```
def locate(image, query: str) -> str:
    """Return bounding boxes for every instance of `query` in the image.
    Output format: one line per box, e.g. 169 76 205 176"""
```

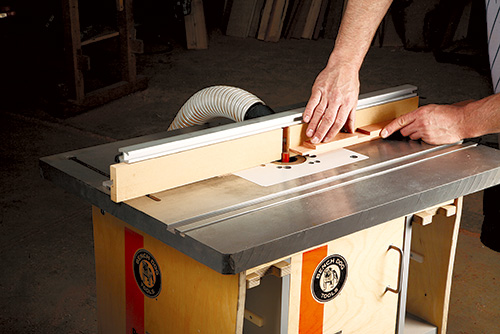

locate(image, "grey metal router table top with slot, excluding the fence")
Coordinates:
40 120 500 274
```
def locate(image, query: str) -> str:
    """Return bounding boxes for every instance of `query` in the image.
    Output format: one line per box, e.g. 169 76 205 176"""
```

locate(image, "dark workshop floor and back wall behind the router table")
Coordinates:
0 0 500 334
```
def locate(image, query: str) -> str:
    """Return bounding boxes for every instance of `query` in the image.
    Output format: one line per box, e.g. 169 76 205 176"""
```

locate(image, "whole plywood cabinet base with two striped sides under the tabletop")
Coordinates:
93 199 461 334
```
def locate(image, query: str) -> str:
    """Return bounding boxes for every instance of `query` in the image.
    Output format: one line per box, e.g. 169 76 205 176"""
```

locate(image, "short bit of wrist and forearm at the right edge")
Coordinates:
460 93 500 138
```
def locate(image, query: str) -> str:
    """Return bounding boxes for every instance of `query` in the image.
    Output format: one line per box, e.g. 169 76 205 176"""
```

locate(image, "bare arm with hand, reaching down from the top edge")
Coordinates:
303 0 392 143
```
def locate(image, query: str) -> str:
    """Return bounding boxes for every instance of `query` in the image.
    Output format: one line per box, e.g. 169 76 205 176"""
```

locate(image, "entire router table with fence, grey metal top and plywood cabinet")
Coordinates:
40 86 500 334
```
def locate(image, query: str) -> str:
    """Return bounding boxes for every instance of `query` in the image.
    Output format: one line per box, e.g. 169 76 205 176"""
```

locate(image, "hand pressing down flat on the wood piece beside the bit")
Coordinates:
303 66 359 144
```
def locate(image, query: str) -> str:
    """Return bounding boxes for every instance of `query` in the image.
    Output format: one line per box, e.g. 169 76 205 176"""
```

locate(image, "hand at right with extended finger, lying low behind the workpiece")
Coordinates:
380 104 465 145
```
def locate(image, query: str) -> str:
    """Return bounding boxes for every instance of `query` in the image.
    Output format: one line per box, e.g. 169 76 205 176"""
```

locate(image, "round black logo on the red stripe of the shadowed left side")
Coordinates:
134 249 161 298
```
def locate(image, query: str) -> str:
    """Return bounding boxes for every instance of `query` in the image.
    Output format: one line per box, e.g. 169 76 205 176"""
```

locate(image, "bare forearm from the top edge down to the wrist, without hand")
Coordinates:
327 0 392 71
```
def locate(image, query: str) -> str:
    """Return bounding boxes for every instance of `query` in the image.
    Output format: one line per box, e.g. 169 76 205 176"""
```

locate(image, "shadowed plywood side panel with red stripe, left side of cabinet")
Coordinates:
93 207 245 334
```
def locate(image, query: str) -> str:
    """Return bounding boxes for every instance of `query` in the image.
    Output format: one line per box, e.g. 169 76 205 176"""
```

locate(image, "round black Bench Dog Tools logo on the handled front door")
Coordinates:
311 254 347 303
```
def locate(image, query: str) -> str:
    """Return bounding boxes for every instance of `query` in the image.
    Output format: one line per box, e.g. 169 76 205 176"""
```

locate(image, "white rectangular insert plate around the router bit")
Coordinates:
233 148 368 187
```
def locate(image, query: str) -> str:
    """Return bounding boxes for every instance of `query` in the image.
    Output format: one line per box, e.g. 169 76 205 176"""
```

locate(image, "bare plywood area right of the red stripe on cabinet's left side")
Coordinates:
144 226 239 334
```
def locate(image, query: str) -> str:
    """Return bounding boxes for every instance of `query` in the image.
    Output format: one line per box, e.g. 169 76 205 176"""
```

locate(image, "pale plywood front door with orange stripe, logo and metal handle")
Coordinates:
288 217 405 334
